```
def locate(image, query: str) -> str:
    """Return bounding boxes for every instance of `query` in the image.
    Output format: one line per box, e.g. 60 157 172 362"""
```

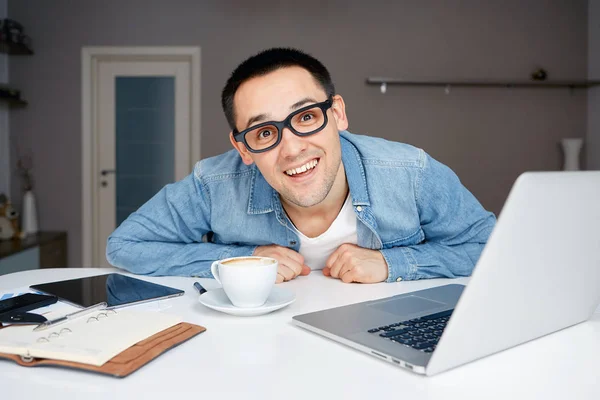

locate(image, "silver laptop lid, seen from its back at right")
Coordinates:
426 171 600 375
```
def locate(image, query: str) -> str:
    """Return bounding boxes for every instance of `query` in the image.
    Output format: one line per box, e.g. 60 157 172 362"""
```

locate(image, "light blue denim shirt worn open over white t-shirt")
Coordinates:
106 131 496 282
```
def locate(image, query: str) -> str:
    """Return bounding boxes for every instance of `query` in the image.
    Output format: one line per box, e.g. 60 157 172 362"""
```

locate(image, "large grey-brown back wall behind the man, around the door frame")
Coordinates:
8 0 588 265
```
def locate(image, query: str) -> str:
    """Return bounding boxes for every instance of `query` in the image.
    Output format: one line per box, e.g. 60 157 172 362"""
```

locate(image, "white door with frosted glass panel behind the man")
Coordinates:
93 61 191 267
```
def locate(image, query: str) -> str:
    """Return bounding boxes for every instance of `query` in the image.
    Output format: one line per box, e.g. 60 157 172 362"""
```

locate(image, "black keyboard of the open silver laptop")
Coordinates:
368 310 454 353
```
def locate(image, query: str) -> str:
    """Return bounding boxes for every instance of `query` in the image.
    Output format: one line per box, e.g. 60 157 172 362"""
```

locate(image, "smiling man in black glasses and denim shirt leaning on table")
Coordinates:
106 48 495 283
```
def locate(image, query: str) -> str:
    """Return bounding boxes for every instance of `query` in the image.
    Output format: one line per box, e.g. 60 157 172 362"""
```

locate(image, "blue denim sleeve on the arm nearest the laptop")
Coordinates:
381 155 496 282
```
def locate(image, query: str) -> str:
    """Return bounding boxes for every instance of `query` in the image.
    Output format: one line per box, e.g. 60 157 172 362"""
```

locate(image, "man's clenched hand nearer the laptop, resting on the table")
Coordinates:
323 243 388 283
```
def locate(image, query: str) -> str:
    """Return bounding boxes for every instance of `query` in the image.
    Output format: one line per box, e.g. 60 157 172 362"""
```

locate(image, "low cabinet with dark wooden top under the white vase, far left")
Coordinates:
0 232 68 275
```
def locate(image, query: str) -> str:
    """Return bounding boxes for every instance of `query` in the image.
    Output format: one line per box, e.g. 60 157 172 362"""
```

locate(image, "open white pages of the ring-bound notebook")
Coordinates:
0 310 181 366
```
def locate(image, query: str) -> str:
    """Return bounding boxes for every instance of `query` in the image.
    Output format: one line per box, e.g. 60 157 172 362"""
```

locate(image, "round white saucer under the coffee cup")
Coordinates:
199 287 296 317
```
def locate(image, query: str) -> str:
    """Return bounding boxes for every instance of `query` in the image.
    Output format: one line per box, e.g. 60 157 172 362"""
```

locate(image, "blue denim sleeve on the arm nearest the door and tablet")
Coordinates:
106 170 256 277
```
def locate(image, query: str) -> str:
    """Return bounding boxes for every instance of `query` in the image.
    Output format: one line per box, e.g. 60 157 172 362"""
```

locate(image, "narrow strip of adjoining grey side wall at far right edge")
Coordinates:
585 0 600 169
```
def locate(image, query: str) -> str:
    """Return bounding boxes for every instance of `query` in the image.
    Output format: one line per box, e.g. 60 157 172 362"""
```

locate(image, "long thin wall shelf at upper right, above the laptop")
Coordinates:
367 77 600 93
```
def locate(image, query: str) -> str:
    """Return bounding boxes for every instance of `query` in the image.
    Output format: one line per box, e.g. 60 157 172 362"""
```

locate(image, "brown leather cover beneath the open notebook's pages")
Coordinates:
0 322 206 378
